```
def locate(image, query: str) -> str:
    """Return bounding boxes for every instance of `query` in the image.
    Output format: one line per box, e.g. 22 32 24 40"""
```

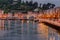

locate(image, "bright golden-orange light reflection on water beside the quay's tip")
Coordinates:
37 23 48 40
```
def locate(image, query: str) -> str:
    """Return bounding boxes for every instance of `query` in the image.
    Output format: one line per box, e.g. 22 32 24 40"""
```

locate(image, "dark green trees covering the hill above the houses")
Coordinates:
0 0 55 13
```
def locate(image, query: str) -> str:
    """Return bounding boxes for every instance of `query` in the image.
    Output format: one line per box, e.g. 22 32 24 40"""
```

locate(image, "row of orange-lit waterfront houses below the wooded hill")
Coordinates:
0 7 60 19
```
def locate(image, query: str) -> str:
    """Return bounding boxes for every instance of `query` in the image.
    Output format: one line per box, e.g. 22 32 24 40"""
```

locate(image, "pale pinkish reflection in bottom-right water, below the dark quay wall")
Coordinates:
48 28 60 40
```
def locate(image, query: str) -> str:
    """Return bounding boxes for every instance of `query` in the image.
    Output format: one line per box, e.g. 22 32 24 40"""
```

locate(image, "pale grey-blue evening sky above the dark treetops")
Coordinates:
22 0 60 7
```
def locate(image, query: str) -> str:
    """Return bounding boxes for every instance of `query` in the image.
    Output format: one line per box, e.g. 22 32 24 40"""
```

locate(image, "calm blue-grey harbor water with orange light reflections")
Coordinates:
0 20 60 40
